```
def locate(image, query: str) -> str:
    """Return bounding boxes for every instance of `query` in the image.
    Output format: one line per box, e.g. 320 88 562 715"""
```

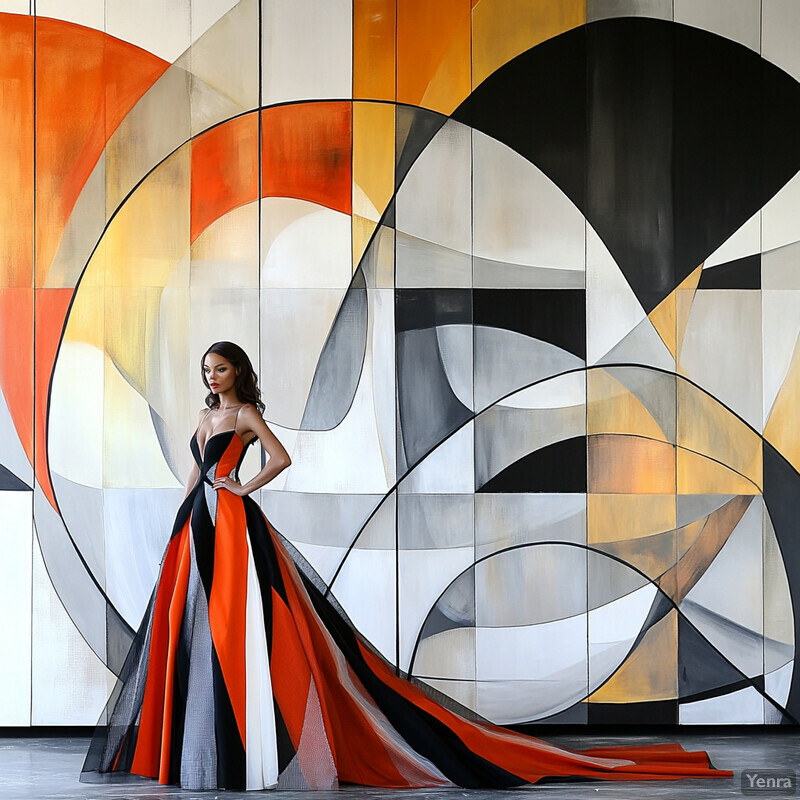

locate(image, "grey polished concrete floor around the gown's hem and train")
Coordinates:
0 728 800 800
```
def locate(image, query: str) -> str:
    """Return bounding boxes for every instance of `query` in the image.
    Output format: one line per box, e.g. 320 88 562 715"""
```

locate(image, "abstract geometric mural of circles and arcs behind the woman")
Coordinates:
0 0 800 726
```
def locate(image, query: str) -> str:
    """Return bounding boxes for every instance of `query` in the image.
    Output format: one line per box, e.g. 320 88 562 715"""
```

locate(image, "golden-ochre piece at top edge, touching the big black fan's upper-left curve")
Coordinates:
472 0 586 87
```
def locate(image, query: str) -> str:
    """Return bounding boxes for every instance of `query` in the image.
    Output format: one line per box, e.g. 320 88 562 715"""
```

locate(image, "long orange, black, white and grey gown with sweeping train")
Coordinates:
82 430 731 790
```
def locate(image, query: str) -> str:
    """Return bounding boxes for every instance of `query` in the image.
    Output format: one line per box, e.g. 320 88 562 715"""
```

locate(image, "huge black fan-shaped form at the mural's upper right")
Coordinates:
453 17 800 312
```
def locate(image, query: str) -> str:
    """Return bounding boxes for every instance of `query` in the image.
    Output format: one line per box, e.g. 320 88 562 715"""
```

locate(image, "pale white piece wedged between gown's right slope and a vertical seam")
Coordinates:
333 550 397 664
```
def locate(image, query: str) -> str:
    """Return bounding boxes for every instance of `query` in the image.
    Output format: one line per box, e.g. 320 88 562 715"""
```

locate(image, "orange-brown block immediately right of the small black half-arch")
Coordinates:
588 434 675 494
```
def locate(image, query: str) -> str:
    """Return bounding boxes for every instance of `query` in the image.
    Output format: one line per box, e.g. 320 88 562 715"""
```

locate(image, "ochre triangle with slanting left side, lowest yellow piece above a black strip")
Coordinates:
589 609 678 703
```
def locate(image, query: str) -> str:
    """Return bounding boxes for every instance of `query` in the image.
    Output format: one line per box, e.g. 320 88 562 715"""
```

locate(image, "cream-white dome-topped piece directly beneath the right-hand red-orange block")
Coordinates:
261 205 353 290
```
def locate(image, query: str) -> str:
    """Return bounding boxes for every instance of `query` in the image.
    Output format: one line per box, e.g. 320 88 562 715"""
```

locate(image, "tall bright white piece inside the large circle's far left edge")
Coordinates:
47 339 105 489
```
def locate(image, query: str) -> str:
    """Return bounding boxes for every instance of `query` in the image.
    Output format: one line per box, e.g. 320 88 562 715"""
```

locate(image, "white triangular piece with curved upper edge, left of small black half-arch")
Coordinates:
398 420 475 494
